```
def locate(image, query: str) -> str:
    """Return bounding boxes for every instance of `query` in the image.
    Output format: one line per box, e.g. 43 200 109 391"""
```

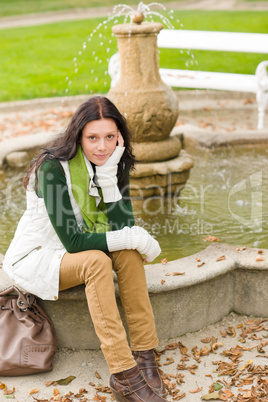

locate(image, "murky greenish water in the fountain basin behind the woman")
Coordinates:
0 147 268 261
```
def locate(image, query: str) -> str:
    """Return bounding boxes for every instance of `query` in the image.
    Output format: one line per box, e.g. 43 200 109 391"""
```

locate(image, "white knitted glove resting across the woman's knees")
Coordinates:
106 226 161 262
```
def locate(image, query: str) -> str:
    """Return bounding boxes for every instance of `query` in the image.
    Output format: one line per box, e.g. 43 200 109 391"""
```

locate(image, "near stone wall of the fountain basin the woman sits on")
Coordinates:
0 243 268 349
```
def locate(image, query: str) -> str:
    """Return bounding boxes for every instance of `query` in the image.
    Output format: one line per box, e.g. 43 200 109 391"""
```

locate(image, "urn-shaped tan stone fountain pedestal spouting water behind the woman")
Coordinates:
107 12 193 199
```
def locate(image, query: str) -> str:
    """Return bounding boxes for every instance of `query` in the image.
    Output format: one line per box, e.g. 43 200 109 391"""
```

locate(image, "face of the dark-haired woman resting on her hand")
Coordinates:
81 119 119 166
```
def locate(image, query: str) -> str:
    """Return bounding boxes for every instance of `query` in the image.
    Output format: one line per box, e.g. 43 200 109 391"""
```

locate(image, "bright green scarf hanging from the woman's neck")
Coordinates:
69 144 110 233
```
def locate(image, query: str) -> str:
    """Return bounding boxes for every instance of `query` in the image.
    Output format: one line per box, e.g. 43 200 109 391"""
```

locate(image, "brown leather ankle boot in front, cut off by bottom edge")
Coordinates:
110 366 166 402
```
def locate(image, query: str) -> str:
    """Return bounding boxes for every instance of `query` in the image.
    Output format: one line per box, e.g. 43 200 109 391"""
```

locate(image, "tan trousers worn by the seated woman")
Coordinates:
60 250 158 373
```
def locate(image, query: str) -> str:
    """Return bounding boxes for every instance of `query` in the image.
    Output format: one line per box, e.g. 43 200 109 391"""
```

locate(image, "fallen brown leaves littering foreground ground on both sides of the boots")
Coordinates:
0 318 268 402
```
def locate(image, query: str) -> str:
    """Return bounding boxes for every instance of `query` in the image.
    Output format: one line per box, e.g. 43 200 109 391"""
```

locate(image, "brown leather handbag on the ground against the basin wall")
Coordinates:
0 286 57 376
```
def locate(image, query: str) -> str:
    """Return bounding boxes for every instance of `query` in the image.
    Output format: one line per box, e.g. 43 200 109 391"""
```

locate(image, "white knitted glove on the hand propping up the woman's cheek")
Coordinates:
96 146 125 203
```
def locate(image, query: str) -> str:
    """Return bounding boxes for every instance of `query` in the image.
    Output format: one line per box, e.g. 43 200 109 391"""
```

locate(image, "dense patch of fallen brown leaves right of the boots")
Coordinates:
157 319 268 402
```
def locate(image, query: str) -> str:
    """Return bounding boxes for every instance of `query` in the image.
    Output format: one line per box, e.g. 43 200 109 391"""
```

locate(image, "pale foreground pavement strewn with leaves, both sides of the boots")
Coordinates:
0 313 268 402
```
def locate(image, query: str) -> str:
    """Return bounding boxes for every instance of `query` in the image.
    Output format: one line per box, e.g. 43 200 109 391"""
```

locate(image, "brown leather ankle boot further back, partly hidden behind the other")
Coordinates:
132 349 167 397
